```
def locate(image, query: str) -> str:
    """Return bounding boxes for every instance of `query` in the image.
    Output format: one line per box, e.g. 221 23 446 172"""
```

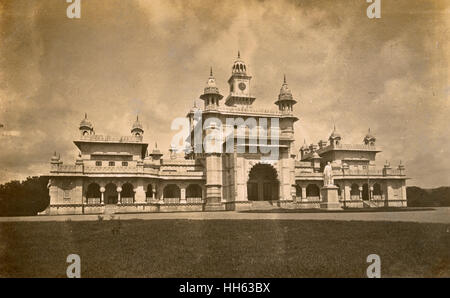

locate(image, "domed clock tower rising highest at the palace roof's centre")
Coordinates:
225 52 255 106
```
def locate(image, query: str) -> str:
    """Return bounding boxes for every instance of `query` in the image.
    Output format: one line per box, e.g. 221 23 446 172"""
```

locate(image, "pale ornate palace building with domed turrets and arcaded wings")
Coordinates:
42 55 407 214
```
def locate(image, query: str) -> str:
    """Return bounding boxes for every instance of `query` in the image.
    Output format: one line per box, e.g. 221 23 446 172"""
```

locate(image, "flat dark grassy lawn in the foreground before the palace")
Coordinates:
0 220 450 277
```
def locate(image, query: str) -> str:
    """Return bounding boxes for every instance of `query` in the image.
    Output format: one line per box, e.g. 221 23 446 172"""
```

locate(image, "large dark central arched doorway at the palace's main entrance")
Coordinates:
247 164 280 201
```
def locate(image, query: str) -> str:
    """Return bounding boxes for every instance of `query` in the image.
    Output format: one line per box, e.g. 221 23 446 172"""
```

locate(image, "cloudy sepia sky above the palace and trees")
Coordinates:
0 0 450 187
